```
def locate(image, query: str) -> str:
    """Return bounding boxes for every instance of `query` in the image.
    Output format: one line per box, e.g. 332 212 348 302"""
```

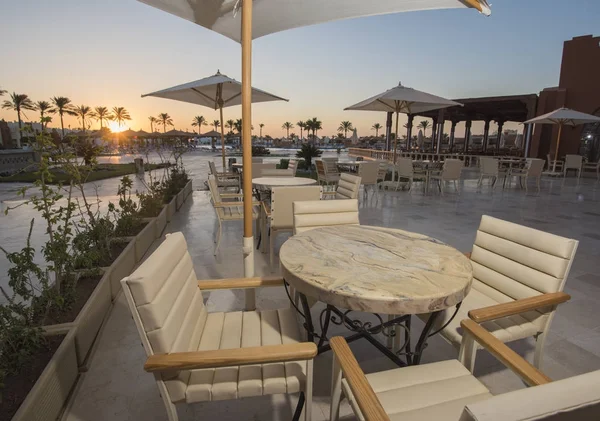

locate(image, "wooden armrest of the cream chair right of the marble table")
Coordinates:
469 292 571 323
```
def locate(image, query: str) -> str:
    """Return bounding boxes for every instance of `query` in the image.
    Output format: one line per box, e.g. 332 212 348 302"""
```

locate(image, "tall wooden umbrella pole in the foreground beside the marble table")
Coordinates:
242 0 255 310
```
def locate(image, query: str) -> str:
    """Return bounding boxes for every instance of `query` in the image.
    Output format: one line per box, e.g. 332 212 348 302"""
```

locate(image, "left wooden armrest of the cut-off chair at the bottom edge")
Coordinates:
329 336 390 421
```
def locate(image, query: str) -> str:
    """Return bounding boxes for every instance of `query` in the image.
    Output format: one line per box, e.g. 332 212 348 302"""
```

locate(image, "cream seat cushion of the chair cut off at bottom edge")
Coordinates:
342 360 492 421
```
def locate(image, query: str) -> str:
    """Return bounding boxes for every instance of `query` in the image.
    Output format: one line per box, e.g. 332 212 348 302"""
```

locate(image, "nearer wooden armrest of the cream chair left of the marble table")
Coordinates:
144 342 317 373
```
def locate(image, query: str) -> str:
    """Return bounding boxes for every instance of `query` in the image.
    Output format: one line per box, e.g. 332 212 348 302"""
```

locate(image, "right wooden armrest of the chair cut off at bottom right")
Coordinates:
460 319 552 386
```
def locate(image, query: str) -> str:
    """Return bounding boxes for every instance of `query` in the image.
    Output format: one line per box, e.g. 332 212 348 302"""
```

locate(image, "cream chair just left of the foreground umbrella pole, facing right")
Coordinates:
208 175 260 256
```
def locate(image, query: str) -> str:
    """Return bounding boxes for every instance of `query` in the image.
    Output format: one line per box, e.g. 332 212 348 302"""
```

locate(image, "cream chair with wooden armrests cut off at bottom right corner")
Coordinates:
330 320 600 421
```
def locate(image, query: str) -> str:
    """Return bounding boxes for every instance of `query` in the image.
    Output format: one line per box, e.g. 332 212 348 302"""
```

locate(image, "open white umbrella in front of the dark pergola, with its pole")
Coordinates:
344 83 462 162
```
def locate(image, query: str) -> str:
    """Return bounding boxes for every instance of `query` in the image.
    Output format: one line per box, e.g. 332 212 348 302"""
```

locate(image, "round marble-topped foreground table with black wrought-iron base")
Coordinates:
279 225 473 366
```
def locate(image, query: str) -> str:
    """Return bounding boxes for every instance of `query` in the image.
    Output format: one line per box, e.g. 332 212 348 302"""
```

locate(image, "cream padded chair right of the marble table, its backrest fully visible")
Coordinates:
424 215 578 368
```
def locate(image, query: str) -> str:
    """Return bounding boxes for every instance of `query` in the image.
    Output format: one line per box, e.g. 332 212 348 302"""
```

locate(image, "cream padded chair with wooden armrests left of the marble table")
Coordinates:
121 233 317 421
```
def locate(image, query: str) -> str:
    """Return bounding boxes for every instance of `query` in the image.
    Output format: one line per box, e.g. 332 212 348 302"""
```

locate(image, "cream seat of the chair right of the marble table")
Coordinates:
420 279 546 347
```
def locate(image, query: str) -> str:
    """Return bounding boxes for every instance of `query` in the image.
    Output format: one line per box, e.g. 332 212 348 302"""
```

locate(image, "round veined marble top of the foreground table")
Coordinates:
279 225 473 315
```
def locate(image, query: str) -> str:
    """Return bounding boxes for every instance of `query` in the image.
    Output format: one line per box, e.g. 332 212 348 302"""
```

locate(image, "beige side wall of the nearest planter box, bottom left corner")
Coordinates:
12 330 79 421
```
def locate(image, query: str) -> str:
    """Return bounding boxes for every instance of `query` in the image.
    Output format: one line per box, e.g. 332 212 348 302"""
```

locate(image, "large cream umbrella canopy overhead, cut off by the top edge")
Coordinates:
139 0 490 42
